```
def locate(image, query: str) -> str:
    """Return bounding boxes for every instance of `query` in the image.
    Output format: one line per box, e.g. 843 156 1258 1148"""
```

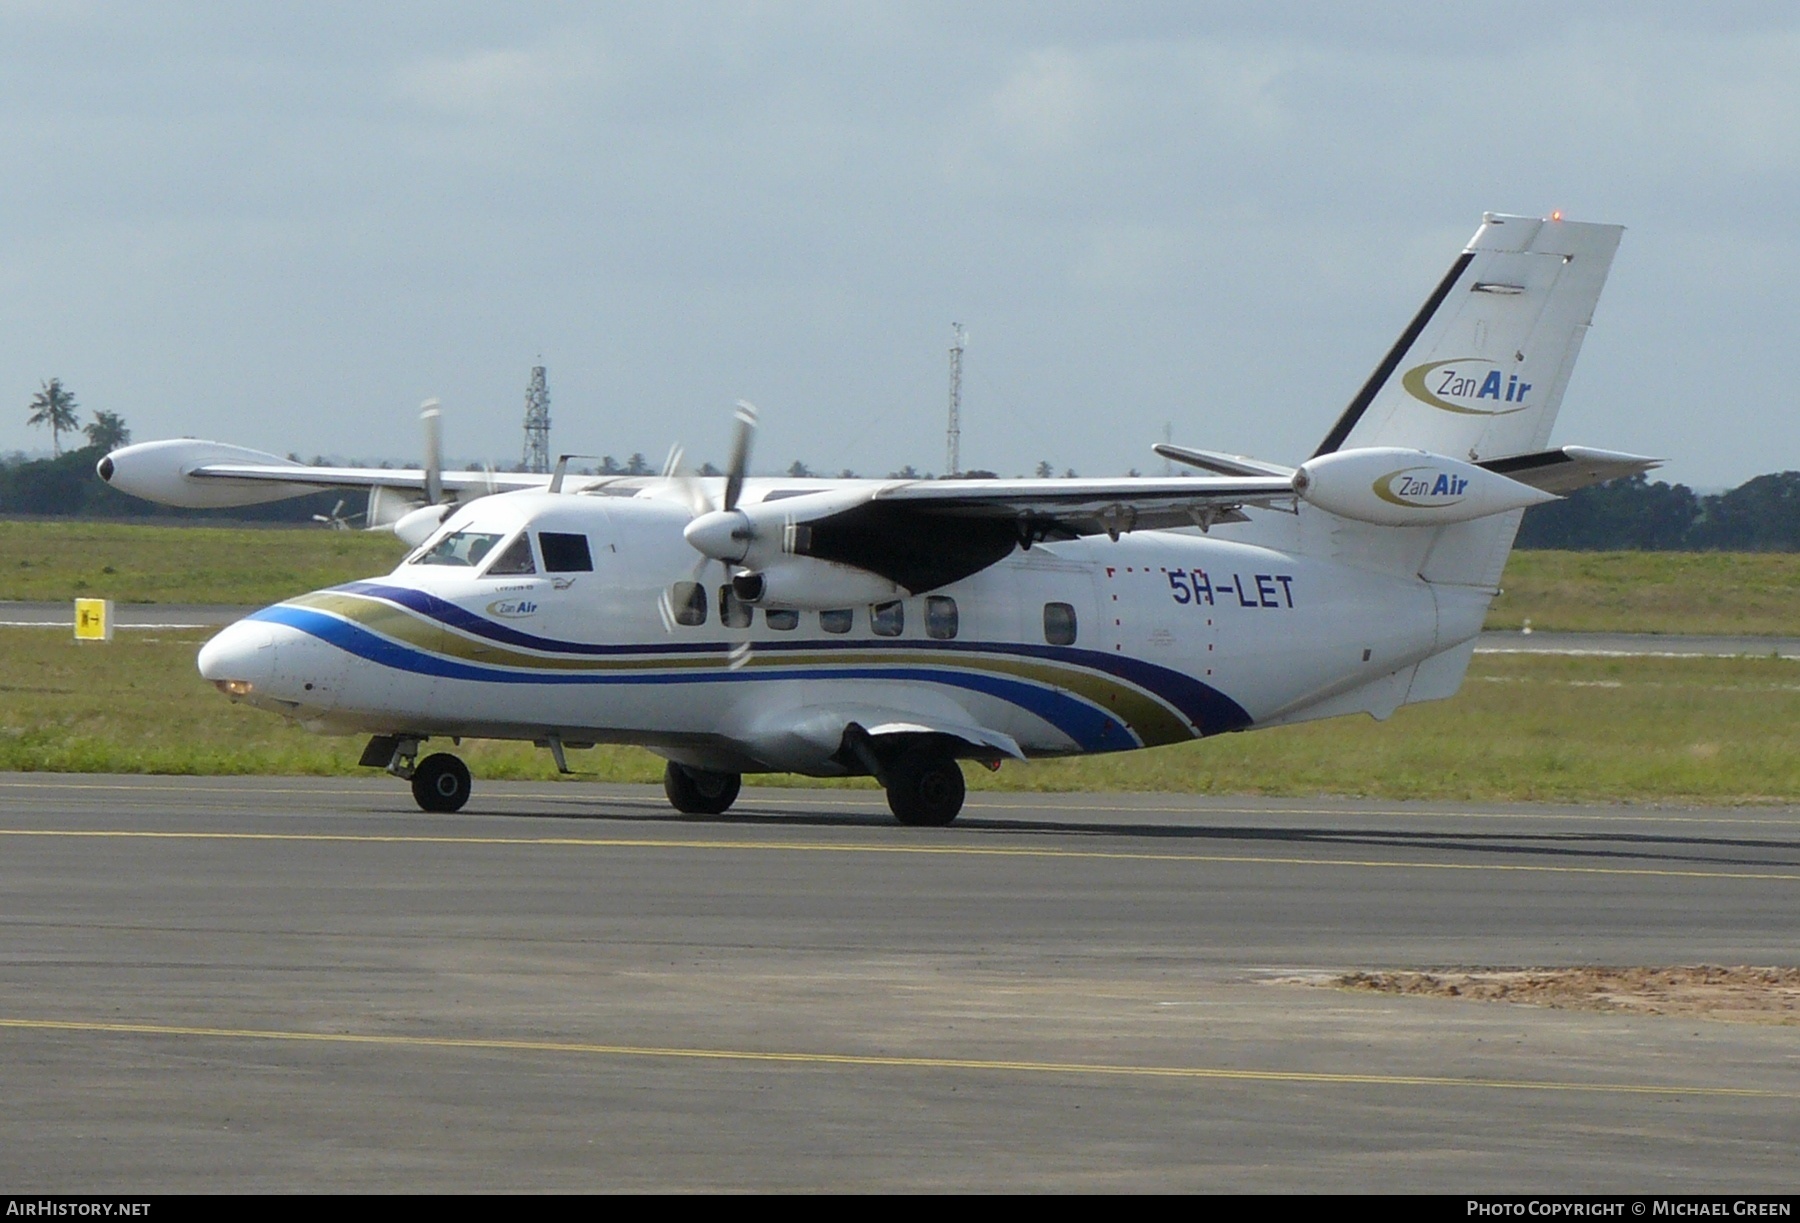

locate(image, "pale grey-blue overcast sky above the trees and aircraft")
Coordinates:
0 0 1800 488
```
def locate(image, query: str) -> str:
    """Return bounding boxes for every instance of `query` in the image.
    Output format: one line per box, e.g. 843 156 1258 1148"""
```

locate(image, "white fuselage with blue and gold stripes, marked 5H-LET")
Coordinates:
200 481 1485 775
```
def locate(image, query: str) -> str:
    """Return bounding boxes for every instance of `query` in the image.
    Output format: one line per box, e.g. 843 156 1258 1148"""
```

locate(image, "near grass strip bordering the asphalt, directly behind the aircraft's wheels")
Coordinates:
0 629 1800 802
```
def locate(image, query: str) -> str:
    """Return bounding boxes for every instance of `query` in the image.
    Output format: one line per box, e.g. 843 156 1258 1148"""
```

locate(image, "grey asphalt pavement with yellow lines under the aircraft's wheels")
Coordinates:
0 775 1800 1194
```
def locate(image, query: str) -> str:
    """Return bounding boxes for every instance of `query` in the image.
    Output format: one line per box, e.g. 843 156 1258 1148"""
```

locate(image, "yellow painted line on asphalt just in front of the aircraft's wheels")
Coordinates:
0 829 1800 883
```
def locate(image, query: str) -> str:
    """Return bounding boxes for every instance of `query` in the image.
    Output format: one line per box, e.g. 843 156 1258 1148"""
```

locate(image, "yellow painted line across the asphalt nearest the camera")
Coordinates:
0 1019 1800 1101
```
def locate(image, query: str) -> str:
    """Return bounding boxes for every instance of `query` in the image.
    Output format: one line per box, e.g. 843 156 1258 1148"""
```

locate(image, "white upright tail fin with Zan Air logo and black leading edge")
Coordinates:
1318 213 1624 461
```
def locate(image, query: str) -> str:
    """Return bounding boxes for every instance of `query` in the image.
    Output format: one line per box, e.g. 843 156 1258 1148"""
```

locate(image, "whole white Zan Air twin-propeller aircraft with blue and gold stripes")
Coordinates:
99 214 1656 825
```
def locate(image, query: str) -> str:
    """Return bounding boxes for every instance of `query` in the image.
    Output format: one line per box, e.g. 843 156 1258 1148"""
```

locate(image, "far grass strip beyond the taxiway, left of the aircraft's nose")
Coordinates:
0 521 407 605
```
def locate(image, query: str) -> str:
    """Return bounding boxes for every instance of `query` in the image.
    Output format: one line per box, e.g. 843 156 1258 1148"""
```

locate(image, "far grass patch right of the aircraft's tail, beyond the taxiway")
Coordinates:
1487 551 1800 636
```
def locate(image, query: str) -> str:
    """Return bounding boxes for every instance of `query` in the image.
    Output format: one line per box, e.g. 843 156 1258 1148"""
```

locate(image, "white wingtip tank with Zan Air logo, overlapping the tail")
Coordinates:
1294 447 1557 526
